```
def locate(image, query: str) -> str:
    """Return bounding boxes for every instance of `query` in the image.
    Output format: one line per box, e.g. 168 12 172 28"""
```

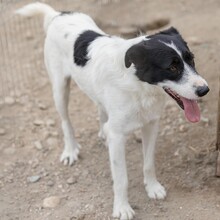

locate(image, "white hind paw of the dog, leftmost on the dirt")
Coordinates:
60 146 80 166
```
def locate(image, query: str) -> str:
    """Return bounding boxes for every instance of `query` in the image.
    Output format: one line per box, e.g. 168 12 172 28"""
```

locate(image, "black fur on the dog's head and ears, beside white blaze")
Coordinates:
125 28 194 84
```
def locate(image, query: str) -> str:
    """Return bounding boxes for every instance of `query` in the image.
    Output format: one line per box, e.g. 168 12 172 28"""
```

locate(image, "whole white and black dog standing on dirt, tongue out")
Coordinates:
16 3 209 220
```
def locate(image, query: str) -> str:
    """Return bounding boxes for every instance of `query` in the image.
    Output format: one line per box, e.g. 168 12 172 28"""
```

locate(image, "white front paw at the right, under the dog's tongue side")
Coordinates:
145 181 166 199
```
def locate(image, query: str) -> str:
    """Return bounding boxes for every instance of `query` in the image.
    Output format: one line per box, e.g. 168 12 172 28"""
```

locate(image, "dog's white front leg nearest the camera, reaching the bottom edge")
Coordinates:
104 126 135 220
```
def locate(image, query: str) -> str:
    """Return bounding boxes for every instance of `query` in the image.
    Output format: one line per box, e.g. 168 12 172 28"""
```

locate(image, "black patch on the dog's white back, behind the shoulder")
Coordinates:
73 31 103 66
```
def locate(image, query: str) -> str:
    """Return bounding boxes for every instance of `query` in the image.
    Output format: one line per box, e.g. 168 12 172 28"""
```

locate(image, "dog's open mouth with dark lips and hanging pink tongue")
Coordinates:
163 87 200 123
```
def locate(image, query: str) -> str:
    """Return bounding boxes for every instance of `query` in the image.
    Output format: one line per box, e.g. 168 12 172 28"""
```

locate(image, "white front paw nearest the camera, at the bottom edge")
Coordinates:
113 204 135 220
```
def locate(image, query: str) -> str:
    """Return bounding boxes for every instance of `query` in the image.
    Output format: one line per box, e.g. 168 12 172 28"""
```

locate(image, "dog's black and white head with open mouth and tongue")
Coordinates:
125 27 209 122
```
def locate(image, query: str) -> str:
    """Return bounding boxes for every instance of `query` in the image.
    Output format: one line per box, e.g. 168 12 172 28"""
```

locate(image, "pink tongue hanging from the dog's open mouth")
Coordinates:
181 97 200 123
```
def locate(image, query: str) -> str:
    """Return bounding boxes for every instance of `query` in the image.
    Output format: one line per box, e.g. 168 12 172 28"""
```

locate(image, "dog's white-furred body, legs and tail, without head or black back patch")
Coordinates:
17 3 208 220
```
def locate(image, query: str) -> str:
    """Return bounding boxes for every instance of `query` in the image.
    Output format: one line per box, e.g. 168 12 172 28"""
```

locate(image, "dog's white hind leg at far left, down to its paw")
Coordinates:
52 77 79 165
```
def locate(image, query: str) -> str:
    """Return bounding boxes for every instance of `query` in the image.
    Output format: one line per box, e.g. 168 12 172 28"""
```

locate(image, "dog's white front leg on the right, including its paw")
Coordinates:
142 120 166 199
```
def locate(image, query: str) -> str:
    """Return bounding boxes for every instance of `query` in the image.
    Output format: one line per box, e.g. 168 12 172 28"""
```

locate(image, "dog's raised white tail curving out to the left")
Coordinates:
15 2 59 33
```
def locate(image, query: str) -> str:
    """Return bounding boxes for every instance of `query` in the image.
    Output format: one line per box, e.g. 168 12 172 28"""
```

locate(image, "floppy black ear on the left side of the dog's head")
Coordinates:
125 44 146 68
